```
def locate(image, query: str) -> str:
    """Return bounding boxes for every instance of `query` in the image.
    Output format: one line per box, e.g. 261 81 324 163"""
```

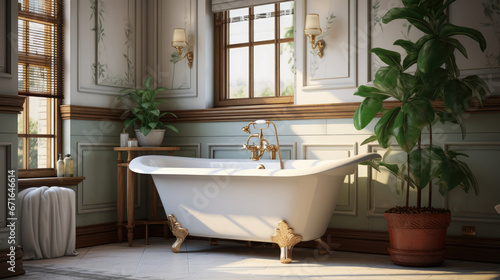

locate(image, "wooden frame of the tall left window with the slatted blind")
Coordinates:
18 0 64 178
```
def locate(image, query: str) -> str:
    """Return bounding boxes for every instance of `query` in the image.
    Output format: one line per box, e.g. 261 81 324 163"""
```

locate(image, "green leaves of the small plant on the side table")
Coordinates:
118 77 179 135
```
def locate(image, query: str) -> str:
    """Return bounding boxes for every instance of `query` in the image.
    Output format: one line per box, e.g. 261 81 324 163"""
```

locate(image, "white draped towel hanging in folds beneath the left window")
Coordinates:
17 187 78 259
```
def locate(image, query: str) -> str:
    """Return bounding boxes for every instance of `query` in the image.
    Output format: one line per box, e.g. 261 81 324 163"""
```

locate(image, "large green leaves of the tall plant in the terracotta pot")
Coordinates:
353 0 489 207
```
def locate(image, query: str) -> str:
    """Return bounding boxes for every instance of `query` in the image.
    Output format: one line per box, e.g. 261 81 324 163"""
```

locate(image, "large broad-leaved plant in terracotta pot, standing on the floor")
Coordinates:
354 0 489 266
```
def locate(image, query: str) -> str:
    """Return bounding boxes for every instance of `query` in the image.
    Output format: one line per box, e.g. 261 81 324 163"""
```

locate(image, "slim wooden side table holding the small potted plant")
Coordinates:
114 147 180 246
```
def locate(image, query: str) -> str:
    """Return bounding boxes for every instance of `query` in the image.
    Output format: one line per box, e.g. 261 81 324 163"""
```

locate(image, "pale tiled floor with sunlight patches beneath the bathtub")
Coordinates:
15 238 500 280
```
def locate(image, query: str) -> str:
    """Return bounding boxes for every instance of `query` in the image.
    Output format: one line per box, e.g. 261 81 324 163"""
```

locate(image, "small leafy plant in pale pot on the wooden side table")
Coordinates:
118 77 179 147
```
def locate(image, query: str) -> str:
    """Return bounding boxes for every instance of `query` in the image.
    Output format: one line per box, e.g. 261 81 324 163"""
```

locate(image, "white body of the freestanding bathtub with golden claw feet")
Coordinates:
129 154 380 262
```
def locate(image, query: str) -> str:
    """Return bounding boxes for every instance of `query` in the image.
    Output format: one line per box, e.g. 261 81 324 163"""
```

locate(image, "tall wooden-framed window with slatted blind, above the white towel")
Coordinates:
18 0 63 177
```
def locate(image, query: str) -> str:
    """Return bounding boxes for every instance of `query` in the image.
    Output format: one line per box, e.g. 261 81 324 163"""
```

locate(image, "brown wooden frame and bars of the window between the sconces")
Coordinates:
214 3 294 107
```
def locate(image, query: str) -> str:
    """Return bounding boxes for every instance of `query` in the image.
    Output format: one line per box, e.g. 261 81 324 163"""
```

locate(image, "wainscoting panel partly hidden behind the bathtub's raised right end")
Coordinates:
302 143 358 216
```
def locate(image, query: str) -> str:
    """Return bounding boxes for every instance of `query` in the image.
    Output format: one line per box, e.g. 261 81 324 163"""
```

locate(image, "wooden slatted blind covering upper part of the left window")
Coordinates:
18 0 63 98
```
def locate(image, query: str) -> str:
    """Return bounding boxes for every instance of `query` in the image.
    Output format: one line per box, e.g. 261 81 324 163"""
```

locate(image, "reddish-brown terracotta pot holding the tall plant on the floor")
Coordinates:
384 212 451 266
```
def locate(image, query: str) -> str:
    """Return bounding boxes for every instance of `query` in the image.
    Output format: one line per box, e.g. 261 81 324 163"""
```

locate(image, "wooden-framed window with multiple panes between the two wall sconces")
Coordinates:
215 1 295 106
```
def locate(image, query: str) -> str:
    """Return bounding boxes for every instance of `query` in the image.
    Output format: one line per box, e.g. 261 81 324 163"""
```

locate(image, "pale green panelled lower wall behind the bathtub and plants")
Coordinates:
68 114 500 237
